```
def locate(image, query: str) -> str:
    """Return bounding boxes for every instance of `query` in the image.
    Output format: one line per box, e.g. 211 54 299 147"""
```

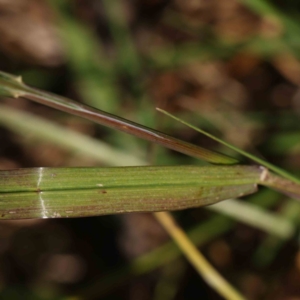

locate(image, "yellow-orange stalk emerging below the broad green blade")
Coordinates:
155 212 245 300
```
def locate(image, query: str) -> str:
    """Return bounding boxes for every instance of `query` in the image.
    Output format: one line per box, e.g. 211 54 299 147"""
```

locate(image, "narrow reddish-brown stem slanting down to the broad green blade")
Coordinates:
0 72 238 164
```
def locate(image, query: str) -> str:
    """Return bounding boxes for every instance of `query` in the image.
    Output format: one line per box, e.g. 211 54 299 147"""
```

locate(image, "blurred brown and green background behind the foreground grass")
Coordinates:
0 0 300 300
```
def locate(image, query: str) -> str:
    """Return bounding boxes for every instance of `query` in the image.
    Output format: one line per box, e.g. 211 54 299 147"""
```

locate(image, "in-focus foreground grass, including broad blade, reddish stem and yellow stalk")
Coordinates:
0 73 300 299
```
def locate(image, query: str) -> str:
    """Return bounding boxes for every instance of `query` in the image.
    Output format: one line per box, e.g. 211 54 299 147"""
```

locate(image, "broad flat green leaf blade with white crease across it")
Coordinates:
0 166 262 219
